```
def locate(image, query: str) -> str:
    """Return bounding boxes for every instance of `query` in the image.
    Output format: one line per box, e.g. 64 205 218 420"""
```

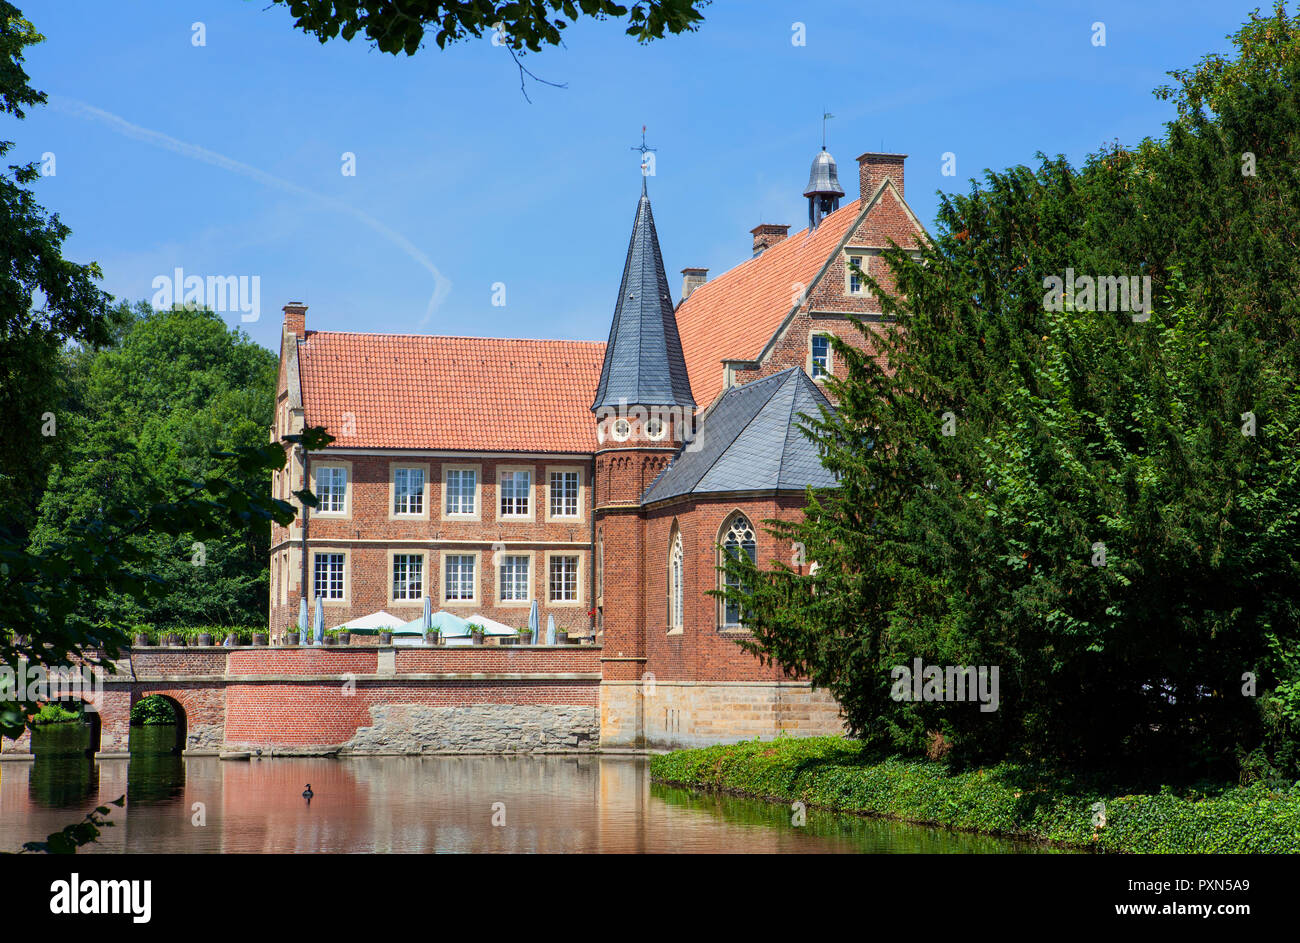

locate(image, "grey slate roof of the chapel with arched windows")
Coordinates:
641 367 836 505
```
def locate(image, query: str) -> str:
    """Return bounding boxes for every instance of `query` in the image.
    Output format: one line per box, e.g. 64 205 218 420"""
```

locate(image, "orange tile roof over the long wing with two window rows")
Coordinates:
298 330 605 453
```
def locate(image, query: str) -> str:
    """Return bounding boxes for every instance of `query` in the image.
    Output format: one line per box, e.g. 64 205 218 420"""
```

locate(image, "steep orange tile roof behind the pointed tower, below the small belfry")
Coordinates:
677 200 862 410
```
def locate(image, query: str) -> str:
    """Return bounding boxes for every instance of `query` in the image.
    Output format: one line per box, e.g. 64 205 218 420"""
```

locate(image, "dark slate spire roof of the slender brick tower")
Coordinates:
592 177 696 410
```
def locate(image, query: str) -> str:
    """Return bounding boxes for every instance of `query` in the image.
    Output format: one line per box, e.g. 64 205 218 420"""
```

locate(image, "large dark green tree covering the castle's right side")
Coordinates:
729 5 1300 778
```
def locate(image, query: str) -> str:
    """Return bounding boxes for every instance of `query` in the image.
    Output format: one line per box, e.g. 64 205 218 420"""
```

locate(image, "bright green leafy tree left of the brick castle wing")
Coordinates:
33 307 277 626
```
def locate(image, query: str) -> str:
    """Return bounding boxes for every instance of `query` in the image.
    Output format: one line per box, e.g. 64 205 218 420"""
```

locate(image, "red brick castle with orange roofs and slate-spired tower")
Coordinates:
270 148 924 747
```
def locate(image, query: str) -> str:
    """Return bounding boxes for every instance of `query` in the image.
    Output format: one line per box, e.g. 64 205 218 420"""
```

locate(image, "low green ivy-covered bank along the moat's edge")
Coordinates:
650 737 1300 853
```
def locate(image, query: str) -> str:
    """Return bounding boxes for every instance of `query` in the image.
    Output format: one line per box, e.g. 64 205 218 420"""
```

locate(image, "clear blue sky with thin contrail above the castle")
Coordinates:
3 0 1256 349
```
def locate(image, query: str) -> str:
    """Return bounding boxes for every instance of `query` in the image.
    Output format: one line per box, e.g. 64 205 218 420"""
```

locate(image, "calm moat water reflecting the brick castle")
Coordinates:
0 724 1053 853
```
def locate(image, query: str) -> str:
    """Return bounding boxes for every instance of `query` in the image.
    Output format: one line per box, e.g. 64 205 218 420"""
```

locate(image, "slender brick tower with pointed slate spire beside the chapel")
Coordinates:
592 177 696 733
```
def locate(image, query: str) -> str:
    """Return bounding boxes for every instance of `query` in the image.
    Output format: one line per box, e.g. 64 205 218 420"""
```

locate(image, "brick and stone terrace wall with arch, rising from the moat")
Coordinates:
4 645 601 753
